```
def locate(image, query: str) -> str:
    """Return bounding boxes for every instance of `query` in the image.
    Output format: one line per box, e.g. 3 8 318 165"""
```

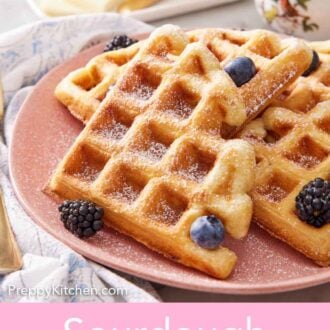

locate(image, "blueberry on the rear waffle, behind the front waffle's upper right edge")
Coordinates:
224 56 257 87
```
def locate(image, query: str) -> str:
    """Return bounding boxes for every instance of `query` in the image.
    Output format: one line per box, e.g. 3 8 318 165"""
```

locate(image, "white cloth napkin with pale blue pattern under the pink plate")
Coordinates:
0 14 159 302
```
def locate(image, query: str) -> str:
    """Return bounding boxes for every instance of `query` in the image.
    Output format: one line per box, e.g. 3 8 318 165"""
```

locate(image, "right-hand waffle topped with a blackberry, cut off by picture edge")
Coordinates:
240 41 330 266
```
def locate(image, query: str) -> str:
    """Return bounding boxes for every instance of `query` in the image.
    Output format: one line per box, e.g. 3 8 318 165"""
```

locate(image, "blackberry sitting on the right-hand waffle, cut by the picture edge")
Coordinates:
296 178 330 228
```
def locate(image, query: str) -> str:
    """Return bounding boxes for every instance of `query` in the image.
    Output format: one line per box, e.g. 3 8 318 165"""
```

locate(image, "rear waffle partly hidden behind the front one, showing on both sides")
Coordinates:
55 29 311 137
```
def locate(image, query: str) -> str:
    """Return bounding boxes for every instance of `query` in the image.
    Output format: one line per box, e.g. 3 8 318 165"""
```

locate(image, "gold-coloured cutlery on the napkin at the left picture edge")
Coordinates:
0 80 22 274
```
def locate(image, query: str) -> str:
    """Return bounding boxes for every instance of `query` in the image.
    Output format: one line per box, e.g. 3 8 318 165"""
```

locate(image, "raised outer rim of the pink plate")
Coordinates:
8 43 330 295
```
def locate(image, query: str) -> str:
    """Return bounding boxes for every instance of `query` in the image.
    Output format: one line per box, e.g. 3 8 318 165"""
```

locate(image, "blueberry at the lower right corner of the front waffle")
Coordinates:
190 215 225 250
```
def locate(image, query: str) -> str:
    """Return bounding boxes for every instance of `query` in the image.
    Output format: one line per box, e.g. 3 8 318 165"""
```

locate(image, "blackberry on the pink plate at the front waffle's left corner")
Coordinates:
58 200 104 238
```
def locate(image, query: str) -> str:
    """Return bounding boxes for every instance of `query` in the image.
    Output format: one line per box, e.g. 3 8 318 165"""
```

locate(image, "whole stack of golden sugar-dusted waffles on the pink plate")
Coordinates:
46 26 330 279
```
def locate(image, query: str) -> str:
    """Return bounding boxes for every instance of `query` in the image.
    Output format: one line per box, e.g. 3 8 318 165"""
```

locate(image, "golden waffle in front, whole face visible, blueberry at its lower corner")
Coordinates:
46 26 255 279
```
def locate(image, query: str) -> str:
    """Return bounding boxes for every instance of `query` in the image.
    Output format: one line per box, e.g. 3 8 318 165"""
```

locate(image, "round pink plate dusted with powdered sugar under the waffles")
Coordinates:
10 40 330 294
